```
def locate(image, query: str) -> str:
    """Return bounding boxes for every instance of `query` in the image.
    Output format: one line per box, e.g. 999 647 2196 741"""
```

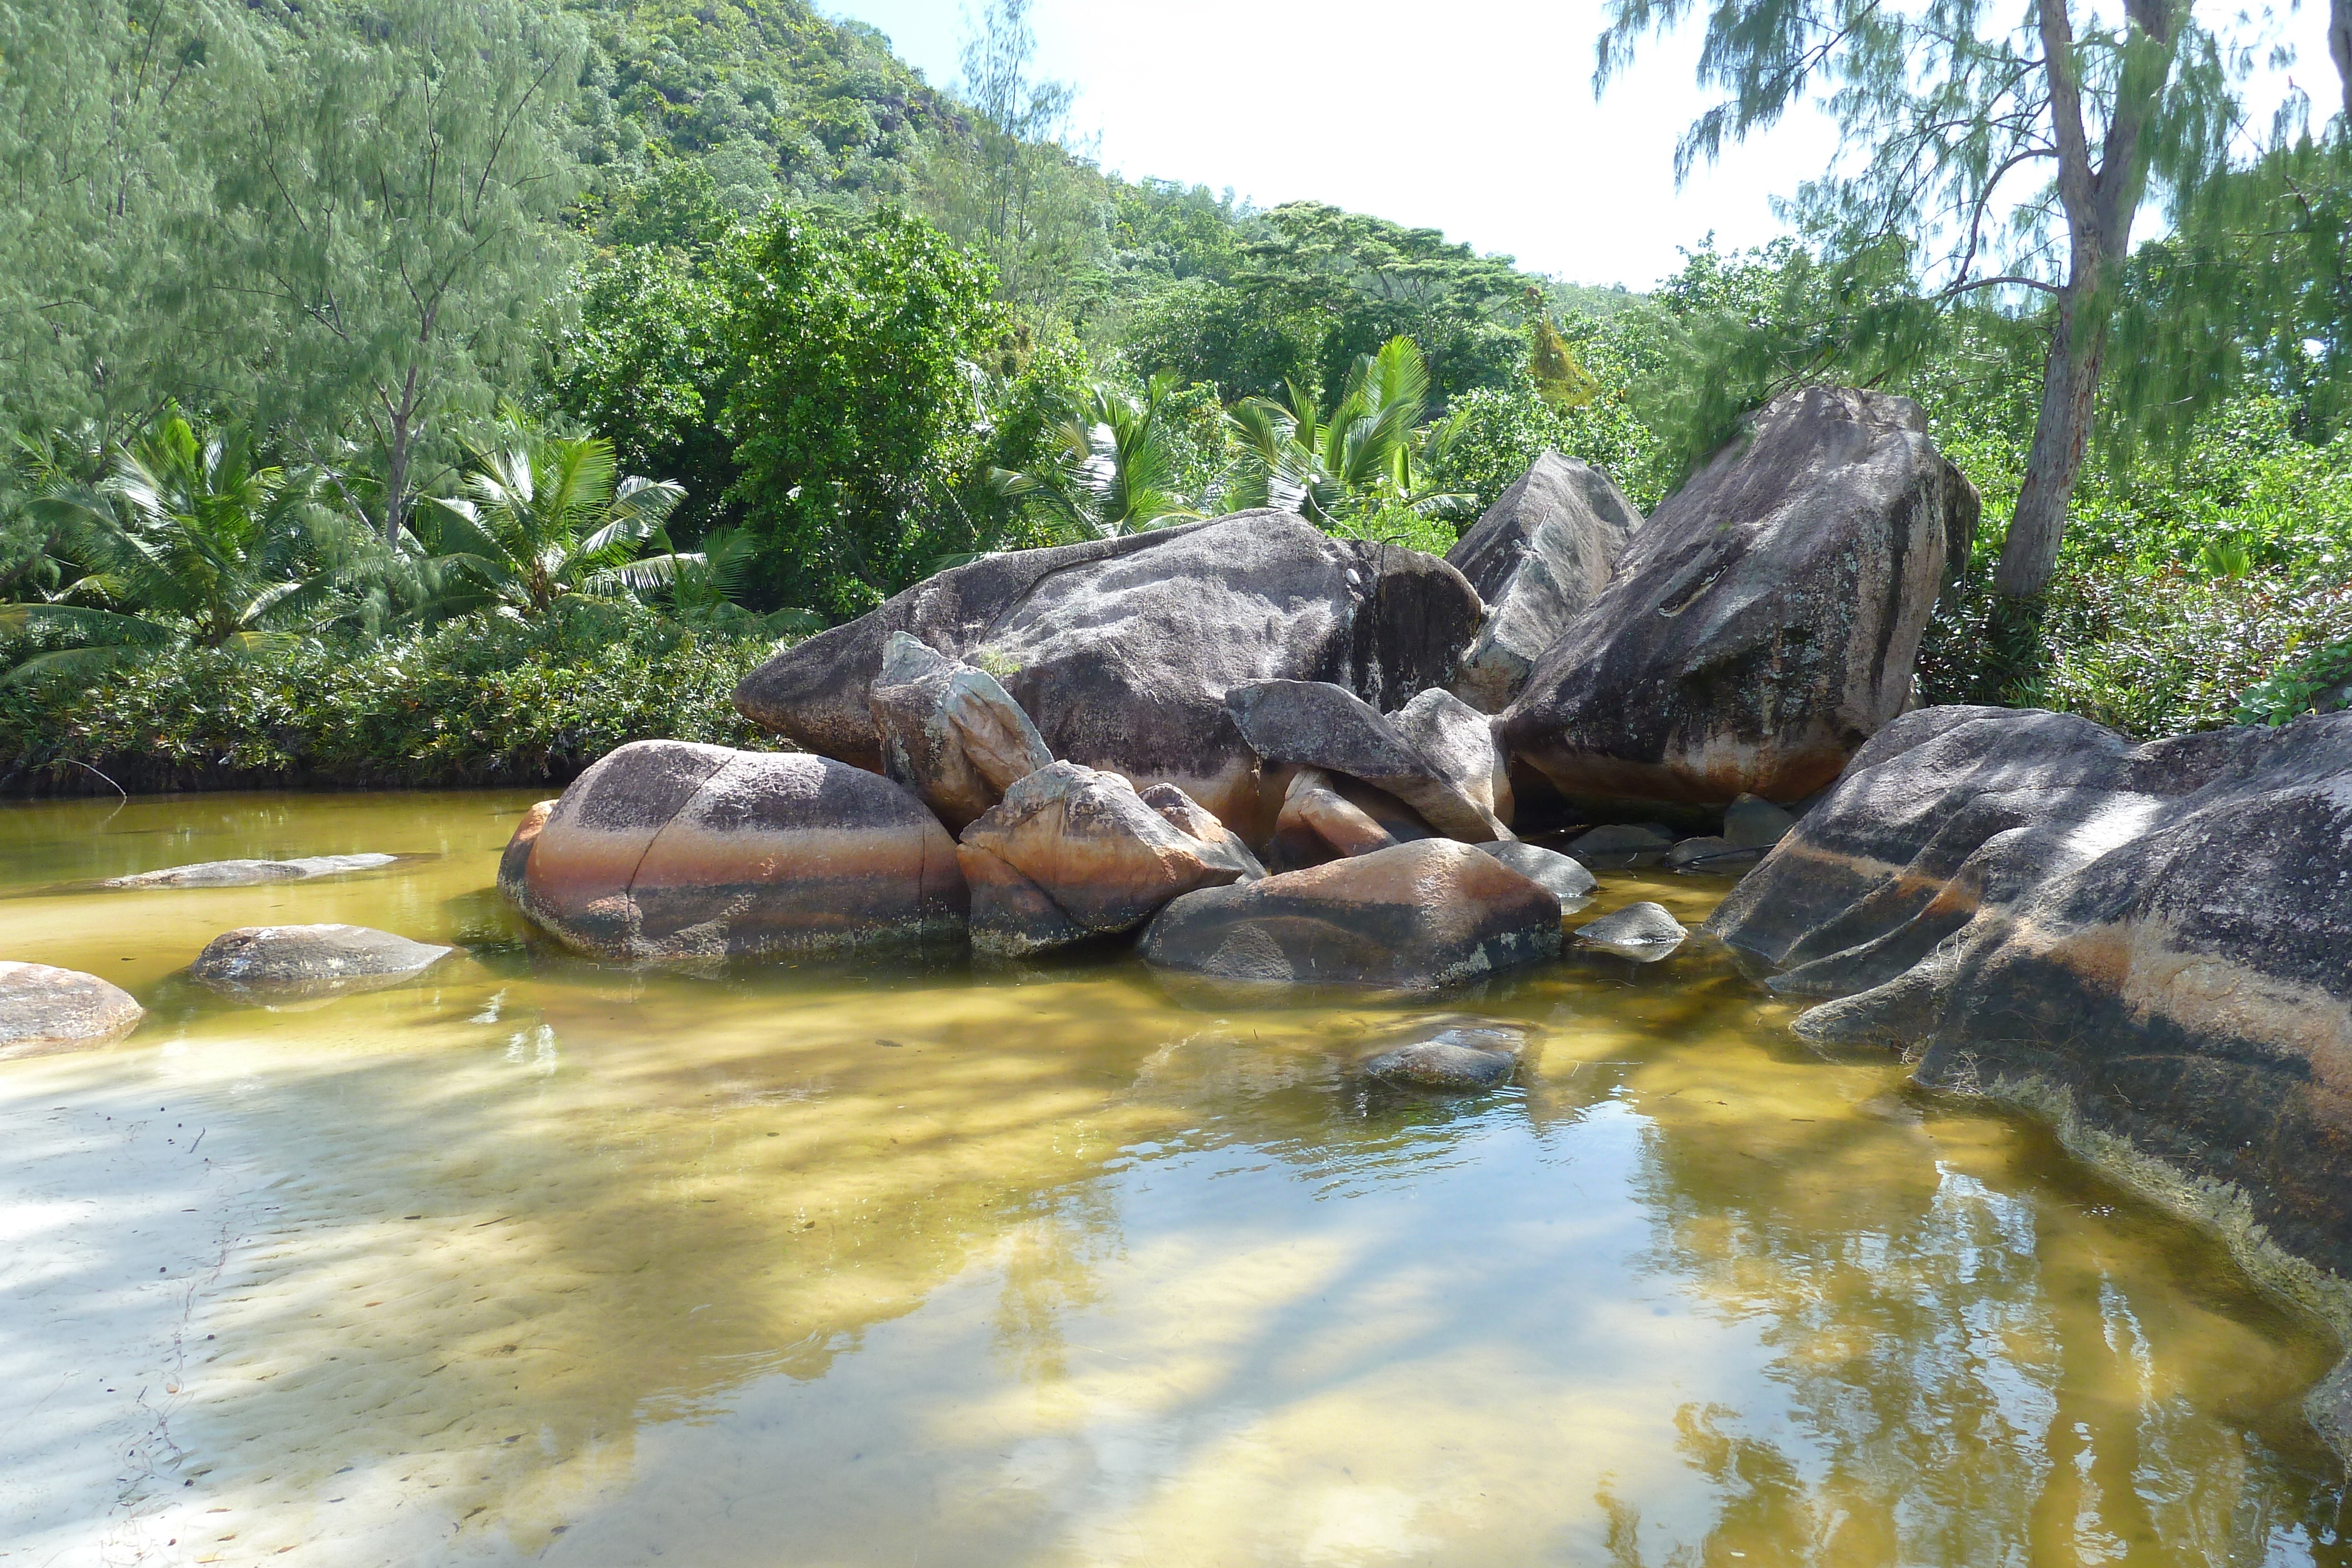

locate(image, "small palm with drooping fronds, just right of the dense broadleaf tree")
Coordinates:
988 374 1200 539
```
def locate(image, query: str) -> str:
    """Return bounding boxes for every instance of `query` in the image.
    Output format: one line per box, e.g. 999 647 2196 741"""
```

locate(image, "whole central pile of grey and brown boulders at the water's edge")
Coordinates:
499 388 1976 989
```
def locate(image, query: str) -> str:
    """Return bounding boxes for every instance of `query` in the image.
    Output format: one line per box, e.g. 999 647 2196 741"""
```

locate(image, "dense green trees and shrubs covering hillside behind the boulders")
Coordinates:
0 0 2352 787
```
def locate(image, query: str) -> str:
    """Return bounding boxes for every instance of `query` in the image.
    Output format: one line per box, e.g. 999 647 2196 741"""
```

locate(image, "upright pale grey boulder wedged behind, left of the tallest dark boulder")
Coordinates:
1446 452 1642 713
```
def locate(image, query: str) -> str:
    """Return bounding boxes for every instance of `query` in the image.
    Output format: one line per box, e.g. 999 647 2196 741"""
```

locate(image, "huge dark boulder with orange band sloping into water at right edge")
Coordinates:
1710 708 2352 1335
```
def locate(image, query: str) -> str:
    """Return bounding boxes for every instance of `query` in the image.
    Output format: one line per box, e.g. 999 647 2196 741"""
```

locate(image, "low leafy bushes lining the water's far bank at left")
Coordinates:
0 600 779 787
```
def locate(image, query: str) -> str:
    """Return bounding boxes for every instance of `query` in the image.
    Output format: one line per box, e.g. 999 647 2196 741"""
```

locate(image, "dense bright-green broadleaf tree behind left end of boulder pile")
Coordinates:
724 209 997 616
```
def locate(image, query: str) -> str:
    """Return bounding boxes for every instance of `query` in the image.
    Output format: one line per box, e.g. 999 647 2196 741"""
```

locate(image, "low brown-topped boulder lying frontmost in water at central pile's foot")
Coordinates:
1143 839 1559 989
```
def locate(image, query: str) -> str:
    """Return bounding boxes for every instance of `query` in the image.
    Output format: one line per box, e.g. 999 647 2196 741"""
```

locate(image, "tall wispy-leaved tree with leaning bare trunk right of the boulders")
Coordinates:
1595 0 2237 597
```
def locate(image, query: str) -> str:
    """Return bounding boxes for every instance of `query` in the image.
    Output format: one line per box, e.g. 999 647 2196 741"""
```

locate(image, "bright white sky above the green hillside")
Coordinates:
818 0 2338 289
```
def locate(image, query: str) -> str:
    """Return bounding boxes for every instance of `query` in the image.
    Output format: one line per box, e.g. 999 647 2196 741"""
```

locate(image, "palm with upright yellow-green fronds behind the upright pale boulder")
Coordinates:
1228 336 1472 531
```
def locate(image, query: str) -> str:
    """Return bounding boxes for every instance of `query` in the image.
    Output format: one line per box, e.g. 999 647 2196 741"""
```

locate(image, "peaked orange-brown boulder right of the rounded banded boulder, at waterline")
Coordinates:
957 762 1256 957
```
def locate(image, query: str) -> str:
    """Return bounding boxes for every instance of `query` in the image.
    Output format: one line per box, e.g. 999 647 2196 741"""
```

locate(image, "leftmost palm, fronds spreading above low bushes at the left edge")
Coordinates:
0 409 339 682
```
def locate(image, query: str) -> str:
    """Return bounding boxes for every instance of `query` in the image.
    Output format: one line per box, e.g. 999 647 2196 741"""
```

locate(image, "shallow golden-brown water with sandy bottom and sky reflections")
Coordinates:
0 792 2345 1568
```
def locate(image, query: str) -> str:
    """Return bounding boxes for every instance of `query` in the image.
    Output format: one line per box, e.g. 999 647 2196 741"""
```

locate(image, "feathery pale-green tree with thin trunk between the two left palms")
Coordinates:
207 0 581 543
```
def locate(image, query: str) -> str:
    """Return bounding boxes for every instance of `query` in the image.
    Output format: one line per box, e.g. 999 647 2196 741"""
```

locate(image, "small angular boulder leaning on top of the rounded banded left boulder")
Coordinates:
868 633 1054 832
